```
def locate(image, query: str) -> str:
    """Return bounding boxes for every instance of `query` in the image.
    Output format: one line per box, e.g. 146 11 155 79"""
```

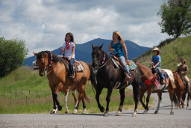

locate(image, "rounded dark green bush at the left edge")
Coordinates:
0 37 27 77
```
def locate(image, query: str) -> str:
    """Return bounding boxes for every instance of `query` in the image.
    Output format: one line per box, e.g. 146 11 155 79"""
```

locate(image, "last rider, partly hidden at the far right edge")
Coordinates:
176 58 189 85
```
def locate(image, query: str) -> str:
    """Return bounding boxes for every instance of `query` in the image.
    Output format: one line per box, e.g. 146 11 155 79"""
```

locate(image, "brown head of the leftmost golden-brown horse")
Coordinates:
34 51 51 76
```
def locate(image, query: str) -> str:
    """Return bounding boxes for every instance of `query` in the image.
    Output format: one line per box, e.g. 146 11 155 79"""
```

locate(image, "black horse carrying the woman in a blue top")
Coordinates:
91 44 139 116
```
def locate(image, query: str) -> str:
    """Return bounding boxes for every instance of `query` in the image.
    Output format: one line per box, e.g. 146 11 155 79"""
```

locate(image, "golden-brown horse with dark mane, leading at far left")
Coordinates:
35 51 90 114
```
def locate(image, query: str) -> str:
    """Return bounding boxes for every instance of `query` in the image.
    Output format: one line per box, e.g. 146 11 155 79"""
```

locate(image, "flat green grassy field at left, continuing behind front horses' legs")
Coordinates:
0 67 134 113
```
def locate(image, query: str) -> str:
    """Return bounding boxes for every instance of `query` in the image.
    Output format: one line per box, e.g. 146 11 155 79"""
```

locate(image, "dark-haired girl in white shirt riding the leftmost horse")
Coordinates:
61 32 76 78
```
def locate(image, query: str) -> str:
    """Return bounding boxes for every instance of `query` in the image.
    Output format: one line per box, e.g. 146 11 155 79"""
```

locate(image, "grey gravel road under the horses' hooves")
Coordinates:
0 93 191 128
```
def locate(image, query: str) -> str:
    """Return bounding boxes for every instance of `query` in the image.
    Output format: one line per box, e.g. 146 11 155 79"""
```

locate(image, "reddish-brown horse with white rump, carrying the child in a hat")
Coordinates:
136 62 176 115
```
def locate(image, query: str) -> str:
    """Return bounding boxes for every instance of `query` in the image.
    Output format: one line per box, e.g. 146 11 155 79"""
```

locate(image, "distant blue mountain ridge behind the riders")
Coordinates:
23 38 150 66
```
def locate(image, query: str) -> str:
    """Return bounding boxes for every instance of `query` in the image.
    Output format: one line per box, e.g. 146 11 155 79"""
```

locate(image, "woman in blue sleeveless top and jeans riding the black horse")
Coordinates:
109 31 132 80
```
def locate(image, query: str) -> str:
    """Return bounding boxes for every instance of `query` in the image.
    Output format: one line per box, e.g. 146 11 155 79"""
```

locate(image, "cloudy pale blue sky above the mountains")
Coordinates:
0 0 168 56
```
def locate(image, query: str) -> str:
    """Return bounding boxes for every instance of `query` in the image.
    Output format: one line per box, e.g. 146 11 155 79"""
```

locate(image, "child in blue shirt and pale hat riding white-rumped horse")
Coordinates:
152 47 165 84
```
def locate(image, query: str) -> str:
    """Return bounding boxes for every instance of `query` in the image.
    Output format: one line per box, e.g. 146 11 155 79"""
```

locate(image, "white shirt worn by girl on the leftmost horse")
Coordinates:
63 42 75 59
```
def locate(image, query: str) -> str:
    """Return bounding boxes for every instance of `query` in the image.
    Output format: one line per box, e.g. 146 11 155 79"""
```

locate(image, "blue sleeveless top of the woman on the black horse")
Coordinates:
111 41 124 57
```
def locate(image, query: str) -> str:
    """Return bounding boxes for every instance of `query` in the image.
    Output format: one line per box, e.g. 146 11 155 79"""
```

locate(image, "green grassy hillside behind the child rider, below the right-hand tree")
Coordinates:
137 36 191 77
